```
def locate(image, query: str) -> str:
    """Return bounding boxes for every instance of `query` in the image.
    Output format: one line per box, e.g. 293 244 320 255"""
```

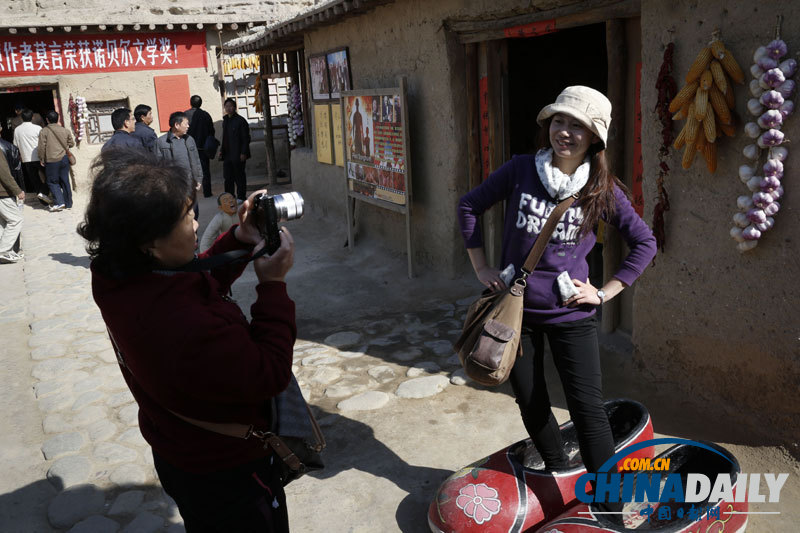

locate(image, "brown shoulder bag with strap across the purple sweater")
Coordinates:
453 196 575 386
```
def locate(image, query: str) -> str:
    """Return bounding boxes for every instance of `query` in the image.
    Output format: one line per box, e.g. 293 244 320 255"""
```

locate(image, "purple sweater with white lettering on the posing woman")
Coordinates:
458 155 656 324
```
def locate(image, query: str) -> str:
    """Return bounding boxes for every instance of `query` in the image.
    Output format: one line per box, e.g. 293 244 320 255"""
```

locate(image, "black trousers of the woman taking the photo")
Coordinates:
153 452 289 533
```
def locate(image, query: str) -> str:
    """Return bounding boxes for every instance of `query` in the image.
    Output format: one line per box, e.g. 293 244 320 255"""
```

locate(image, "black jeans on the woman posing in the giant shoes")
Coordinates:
510 316 614 472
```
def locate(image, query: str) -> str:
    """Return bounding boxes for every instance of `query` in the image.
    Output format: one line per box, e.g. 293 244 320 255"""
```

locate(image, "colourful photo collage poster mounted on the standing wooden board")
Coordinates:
344 94 406 205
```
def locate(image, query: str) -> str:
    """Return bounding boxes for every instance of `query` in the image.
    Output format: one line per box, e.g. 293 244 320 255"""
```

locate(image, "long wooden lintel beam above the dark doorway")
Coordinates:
454 0 641 43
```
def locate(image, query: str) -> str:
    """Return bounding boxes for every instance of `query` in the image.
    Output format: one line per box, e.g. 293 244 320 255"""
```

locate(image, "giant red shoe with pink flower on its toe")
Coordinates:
428 400 654 533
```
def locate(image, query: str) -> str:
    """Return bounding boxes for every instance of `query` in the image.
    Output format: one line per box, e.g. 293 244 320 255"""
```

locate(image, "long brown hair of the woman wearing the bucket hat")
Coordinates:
536 117 630 236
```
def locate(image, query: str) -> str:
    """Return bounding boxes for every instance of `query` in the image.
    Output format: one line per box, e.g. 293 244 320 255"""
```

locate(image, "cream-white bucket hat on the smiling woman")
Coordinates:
536 85 611 148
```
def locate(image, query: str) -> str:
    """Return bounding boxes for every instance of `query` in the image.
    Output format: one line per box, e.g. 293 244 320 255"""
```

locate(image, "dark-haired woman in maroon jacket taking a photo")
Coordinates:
78 150 296 533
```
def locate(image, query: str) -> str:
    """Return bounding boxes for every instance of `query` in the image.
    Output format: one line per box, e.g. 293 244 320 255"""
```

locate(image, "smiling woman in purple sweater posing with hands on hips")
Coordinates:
458 86 656 498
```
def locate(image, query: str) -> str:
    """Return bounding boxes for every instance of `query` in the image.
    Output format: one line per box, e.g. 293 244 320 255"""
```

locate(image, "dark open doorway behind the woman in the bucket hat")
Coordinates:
508 24 608 287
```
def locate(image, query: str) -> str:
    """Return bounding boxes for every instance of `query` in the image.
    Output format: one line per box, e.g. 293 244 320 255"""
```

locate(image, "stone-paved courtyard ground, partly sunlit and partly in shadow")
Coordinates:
0 183 800 533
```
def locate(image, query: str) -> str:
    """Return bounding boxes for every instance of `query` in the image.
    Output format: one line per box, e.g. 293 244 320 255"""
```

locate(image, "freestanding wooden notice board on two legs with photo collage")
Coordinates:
340 78 413 277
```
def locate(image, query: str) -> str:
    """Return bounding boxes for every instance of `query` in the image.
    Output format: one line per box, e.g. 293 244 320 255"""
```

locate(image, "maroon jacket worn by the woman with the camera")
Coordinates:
92 226 297 472
